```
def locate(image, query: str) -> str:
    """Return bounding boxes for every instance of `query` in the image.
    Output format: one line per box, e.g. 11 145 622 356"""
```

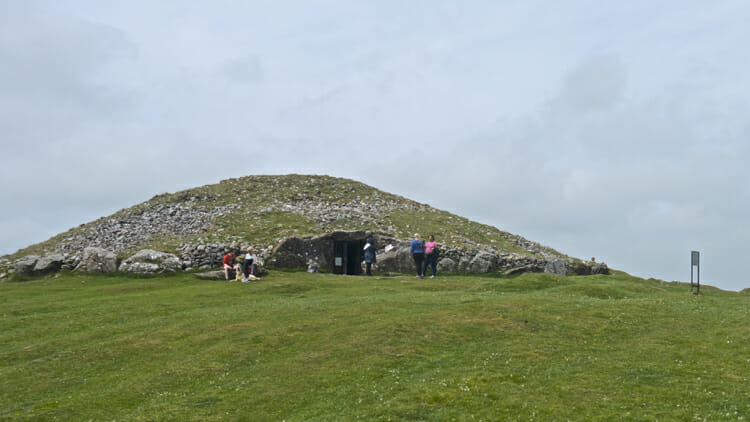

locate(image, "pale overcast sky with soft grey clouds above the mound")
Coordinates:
0 0 750 290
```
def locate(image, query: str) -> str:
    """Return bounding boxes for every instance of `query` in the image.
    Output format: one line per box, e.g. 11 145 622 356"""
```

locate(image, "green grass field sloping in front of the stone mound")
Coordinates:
0 272 750 421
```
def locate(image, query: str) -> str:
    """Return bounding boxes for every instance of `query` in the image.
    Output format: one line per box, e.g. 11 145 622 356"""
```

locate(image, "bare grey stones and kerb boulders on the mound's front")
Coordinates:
1 185 608 275
